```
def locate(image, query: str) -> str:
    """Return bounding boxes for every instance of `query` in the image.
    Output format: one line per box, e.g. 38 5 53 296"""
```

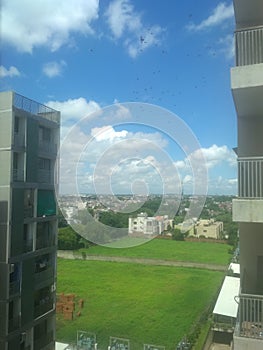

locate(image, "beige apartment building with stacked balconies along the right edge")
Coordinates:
231 0 263 350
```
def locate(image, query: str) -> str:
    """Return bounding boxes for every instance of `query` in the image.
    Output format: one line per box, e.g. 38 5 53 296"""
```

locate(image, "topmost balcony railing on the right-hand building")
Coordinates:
235 26 263 66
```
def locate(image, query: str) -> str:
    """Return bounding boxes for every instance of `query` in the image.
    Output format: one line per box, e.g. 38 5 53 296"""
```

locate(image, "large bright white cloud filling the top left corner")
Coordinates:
1 0 99 53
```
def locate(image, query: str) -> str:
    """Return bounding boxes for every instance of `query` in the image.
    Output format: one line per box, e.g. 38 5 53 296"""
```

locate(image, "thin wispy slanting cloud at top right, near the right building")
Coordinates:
187 2 234 31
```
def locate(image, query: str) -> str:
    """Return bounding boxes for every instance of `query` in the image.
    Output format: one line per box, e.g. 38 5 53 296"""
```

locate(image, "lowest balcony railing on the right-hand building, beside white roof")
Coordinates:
235 293 263 340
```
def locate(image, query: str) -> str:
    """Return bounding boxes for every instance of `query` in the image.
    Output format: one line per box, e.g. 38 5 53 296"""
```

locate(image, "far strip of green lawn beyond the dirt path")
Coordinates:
81 238 231 265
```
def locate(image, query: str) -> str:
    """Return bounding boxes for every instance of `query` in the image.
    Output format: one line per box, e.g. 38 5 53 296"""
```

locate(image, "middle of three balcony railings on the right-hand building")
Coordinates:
238 157 263 199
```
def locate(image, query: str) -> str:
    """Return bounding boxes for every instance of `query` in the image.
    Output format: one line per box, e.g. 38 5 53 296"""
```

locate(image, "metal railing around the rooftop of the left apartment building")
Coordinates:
13 93 60 124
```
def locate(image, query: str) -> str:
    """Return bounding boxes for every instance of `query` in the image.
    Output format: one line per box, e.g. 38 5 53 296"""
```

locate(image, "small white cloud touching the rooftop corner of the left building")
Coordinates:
45 97 100 123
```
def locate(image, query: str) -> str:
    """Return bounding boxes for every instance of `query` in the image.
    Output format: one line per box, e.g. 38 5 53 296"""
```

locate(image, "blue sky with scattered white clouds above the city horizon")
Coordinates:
0 0 237 194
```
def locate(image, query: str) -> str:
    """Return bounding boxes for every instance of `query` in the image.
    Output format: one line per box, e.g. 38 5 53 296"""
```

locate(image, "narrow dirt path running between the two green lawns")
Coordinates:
57 250 227 271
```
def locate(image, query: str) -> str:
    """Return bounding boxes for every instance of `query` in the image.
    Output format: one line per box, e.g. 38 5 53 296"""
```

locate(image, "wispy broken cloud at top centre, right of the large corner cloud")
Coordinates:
105 0 164 58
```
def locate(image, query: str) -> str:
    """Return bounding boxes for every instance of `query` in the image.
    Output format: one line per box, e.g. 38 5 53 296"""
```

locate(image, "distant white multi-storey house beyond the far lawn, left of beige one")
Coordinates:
129 213 172 236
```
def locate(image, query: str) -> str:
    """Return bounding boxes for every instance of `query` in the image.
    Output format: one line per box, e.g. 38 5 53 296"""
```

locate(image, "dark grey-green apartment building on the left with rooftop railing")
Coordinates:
0 92 60 350
